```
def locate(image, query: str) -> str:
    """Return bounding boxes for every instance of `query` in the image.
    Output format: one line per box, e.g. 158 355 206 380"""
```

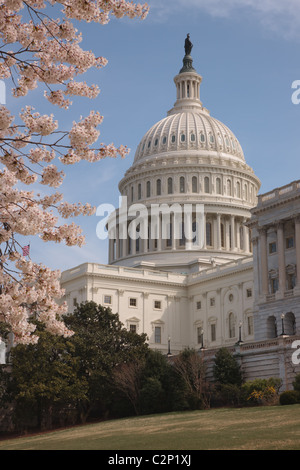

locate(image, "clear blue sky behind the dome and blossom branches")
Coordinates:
7 0 300 271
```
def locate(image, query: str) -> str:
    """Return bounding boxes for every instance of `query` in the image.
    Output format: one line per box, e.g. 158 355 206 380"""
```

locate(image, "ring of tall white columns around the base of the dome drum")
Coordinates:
109 212 251 263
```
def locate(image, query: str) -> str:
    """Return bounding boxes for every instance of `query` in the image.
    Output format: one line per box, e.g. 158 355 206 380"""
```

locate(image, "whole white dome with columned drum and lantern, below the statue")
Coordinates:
109 38 260 272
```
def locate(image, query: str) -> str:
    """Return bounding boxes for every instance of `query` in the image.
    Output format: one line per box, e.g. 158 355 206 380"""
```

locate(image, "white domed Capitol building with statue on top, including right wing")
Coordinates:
61 37 300 389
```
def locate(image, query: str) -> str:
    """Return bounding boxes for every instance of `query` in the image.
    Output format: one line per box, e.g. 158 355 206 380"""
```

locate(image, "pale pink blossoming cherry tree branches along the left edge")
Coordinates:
0 0 148 343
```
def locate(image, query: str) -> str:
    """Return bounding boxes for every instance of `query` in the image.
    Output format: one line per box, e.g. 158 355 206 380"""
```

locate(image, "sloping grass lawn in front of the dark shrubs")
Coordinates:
0 405 300 450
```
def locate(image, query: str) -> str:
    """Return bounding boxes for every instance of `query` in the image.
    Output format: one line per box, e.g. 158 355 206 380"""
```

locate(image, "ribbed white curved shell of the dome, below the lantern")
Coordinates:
134 108 245 163
